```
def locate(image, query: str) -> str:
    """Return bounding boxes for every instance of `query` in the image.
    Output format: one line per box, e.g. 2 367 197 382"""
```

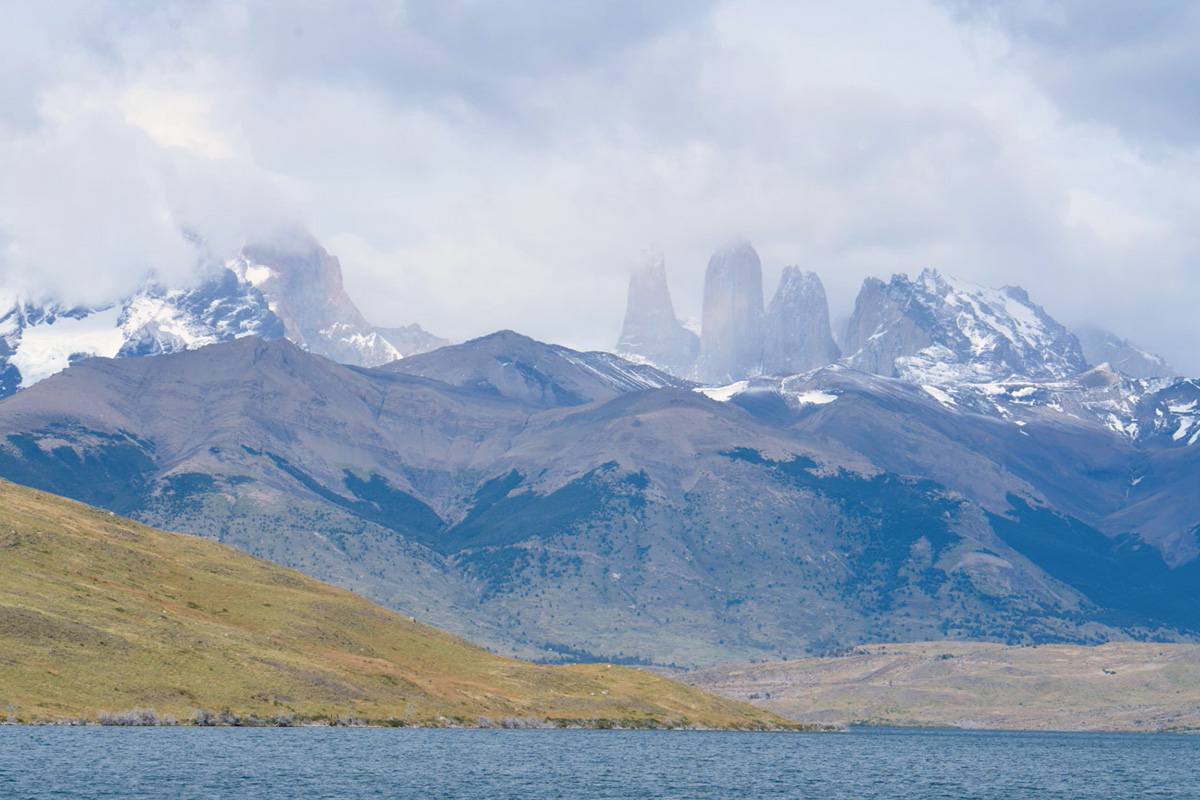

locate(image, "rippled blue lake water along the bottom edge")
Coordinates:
0 727 1200 800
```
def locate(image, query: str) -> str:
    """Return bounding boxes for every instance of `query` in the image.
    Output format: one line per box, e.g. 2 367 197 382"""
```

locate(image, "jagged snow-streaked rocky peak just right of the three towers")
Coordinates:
844 270 1087 385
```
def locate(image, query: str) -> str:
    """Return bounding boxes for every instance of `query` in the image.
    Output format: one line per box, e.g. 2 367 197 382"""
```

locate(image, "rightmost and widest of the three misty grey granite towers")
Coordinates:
762 266 841 373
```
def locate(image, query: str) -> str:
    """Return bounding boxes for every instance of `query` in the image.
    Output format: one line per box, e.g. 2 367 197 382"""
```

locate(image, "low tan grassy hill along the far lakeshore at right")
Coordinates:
682 642 1200 730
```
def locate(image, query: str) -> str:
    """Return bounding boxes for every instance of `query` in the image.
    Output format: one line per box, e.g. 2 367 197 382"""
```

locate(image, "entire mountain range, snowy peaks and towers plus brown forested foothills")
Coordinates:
0 239 1200 666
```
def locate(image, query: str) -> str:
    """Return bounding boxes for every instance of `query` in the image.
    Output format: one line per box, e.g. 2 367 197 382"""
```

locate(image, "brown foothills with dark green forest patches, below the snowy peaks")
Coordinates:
0 333 1200 666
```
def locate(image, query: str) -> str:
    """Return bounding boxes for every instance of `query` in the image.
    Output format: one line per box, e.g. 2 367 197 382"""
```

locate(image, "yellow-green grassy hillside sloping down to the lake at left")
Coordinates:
0 481 787 728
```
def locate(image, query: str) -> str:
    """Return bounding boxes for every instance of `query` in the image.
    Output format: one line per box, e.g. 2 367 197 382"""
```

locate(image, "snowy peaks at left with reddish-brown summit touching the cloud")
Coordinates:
0 234 449 397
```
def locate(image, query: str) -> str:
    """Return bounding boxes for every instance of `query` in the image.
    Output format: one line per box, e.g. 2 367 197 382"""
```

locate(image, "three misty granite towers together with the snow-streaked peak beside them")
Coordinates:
616 240 1178 385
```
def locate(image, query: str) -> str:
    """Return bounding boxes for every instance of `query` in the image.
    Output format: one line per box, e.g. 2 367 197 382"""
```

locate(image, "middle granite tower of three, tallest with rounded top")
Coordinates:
696 241 763 384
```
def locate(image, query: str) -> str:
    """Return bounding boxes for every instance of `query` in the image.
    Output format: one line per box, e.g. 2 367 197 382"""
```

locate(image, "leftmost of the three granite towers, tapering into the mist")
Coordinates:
617 248 700 377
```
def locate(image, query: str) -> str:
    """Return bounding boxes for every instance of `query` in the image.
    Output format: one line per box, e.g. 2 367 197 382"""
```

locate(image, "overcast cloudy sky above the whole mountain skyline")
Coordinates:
0 0 1200 375
